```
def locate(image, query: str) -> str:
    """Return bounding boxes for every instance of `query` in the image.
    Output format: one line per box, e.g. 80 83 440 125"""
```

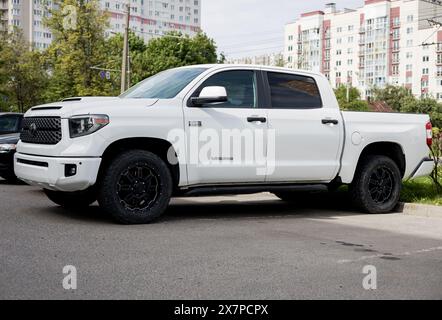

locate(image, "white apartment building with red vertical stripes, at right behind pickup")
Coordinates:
284 0 442 100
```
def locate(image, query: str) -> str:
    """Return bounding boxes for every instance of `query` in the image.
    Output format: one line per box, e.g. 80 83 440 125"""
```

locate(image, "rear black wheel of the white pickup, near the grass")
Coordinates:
350 156 402 214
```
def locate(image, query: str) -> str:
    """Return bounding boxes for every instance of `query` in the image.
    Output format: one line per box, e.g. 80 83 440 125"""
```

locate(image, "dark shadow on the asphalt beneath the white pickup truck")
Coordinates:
40 192 398 224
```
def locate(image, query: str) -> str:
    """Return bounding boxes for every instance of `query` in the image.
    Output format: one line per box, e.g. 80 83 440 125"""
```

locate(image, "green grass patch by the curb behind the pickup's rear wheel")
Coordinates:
401 177 442 206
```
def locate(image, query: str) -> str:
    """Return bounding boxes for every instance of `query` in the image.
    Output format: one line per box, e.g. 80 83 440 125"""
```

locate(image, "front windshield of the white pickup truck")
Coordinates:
120 68 207 99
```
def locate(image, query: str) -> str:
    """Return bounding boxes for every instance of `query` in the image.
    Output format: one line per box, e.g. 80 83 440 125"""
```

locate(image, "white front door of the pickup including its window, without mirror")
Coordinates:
184 69 268 185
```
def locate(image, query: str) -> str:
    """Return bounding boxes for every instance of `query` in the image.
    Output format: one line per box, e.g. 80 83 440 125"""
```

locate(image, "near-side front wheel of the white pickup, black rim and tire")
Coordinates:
98 150 173 224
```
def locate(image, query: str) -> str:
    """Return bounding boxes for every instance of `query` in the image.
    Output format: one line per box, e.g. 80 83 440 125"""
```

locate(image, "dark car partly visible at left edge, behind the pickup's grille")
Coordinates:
0 113 23 182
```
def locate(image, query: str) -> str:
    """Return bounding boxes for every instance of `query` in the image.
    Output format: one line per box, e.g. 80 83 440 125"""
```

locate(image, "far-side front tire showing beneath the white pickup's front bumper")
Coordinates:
44 187 97 209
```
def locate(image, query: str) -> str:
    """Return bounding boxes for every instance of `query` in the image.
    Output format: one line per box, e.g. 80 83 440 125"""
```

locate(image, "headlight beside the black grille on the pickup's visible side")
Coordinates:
69 114 109 138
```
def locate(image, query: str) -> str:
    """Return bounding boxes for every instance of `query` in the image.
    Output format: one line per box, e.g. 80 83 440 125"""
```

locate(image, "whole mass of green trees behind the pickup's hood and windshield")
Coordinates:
0 0 221 112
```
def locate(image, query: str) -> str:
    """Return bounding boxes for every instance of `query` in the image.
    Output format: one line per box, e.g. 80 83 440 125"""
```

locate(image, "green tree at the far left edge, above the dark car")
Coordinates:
0 29 47 112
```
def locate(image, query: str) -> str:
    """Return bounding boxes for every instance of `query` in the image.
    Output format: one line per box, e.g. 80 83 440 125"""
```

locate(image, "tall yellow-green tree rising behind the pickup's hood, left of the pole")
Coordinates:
45 0 114 101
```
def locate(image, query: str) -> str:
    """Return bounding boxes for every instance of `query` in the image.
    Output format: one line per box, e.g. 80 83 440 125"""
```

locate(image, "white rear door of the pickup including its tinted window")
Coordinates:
264 71 343 182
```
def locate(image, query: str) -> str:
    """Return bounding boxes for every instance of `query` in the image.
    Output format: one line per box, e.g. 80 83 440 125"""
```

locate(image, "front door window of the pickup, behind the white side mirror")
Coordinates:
194 70 257 108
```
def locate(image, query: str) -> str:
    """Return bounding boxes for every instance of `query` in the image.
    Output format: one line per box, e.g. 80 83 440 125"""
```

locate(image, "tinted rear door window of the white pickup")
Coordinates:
267 72 322 109
